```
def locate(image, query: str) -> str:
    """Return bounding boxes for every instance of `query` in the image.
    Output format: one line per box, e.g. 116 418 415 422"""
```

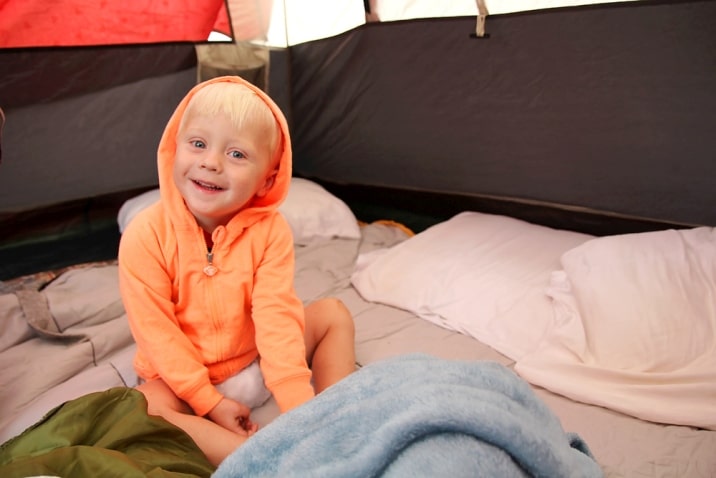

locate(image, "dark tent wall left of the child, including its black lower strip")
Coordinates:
0 44 197 280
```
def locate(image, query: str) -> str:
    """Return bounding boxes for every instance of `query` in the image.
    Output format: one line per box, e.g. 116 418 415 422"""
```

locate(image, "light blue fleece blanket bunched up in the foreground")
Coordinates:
213 355 603 478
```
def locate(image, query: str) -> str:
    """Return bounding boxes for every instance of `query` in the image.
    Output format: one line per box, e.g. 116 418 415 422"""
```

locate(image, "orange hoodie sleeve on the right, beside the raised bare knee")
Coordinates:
252 214 315 412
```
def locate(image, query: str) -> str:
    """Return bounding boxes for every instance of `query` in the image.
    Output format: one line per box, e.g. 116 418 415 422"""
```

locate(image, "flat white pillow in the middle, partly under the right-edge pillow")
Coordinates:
352 212 592 360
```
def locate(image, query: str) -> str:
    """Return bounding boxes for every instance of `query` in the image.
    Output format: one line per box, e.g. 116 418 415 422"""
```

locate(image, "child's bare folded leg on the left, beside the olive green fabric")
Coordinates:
137 379 247 466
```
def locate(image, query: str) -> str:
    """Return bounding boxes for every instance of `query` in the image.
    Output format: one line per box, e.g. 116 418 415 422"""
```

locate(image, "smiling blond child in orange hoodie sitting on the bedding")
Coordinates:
119 77 355 465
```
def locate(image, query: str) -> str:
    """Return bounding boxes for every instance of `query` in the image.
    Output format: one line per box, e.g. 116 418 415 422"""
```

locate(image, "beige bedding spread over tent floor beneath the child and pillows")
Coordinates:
0 224 716 477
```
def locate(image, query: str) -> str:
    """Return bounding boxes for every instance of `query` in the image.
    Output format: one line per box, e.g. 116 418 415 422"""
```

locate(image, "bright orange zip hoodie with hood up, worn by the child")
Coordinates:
119 77 314 415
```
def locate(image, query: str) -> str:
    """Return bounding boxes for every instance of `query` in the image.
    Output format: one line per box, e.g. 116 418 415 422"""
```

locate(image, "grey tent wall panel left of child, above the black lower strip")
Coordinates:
0 44 196 213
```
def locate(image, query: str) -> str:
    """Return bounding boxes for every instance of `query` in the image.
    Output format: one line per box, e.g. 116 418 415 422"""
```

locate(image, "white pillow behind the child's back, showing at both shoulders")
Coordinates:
117 178 360 245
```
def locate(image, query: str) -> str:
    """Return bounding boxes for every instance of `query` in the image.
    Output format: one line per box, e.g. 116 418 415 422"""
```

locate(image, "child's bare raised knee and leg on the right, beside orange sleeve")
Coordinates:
305 298 355 393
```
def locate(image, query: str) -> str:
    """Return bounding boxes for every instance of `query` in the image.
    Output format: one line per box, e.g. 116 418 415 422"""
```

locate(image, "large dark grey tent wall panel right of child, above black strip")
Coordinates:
290 1 716 228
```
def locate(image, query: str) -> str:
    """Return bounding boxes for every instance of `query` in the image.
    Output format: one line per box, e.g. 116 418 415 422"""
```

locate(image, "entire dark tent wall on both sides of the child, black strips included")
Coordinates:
0 0 716 280
